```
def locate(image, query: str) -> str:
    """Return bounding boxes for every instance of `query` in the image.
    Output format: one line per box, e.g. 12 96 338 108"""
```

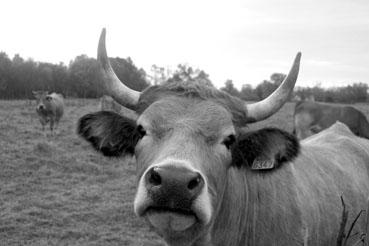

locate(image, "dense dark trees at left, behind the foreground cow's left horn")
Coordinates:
0 52 149 99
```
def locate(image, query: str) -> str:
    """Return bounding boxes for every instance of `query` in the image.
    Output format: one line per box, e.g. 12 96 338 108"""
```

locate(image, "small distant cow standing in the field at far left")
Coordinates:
32 91 64 133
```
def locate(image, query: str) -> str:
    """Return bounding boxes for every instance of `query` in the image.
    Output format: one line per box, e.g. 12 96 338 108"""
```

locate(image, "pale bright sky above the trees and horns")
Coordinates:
0 0 369 88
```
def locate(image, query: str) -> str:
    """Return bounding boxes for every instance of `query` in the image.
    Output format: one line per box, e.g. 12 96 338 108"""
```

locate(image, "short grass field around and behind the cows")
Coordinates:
0 100 369 246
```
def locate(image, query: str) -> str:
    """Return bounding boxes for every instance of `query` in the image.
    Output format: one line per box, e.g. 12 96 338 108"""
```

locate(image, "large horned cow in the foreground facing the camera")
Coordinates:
77 29 369 246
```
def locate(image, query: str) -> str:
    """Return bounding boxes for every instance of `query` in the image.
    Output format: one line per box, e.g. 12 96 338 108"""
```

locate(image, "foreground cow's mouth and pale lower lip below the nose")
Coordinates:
145 207 199 232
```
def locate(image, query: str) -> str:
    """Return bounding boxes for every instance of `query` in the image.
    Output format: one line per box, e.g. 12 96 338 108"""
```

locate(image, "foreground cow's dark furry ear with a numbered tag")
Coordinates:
231 128 300 170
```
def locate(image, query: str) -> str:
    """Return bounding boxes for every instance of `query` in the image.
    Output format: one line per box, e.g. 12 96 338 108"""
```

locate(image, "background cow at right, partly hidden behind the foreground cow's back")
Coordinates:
293 101 369 139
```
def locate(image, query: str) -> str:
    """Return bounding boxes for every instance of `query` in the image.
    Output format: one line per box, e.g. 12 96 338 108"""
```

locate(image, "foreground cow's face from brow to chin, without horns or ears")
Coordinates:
134 98 235 238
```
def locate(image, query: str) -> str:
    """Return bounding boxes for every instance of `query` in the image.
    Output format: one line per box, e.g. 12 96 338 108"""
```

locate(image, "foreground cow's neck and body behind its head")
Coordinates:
212 123 369 246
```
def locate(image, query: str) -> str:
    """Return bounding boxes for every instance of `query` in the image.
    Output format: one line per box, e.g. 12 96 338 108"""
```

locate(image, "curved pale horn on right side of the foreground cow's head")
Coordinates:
245 52 301 123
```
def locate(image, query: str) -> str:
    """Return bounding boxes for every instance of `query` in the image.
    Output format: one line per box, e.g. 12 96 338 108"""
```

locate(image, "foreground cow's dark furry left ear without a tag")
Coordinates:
77 111 139 156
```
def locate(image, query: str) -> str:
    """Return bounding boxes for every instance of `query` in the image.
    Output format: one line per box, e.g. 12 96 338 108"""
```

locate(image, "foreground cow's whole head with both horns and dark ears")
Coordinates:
78 30 300 245
